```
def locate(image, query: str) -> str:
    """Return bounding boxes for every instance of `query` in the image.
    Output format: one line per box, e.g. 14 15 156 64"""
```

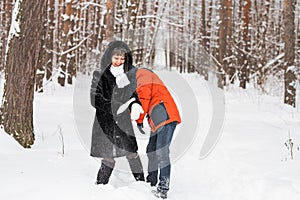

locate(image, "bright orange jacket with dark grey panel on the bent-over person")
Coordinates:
136 68 181 132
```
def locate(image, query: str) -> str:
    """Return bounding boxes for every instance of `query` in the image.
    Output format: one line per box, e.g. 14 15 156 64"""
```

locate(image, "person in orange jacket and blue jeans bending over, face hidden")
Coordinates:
136 68 181 199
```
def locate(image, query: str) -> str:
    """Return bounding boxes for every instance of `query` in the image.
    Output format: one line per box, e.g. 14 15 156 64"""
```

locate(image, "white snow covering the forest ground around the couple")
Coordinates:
0 71 300 200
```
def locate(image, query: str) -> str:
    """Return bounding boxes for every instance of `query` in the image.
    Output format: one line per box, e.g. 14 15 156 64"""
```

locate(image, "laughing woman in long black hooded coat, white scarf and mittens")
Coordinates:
90 41 144 184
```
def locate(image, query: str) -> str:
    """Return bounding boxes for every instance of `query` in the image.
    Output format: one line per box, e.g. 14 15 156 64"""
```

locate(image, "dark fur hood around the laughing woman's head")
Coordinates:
101 41 132 72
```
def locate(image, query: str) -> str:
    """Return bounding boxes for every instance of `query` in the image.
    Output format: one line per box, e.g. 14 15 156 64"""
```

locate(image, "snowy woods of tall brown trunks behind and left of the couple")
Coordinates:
0 0 300 147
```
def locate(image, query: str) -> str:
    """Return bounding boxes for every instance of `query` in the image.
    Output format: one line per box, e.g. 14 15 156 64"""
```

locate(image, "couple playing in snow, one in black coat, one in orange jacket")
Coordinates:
90 41 181 198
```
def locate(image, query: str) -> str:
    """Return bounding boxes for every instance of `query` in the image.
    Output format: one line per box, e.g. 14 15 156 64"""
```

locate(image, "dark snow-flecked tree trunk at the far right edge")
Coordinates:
284 0 297 107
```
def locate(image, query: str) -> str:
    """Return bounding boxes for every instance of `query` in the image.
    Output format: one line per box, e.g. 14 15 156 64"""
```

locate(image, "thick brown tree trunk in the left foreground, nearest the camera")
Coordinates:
0 0 47 148
